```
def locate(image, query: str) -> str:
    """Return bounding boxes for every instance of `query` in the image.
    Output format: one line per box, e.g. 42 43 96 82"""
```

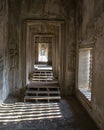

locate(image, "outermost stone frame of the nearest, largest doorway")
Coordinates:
22 20 64 86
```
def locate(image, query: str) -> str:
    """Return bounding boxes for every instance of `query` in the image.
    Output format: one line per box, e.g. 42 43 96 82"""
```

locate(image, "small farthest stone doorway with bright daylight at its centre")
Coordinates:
33 35 53 66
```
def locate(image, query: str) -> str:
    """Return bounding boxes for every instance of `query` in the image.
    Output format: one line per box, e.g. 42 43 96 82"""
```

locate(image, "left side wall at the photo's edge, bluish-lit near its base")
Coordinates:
0 0 9 103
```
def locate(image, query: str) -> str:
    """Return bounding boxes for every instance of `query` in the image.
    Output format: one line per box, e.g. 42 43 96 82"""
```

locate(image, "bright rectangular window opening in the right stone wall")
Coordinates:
78 48 93 101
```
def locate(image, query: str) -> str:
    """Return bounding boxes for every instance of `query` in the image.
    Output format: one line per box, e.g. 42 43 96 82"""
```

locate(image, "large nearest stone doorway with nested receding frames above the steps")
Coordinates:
23 20 64 85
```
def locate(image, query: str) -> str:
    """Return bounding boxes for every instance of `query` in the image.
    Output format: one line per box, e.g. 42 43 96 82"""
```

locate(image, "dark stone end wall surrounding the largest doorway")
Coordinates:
8 0 75 95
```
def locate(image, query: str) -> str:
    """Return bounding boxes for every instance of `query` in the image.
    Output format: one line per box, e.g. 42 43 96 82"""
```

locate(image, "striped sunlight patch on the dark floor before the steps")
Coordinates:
0 103 62 123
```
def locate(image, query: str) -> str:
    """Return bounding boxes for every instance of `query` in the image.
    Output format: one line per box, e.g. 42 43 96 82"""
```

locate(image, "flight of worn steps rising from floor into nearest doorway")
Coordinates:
24 70 61 102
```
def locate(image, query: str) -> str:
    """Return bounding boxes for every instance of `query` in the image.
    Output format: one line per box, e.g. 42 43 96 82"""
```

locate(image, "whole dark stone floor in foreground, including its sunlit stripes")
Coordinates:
0 98 98 130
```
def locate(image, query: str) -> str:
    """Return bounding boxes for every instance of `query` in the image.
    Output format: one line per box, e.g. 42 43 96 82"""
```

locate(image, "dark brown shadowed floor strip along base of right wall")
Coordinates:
67 97 100 130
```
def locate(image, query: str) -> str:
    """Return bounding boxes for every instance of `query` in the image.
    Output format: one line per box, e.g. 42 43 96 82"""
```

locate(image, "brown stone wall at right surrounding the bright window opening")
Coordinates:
76 0 104 130
